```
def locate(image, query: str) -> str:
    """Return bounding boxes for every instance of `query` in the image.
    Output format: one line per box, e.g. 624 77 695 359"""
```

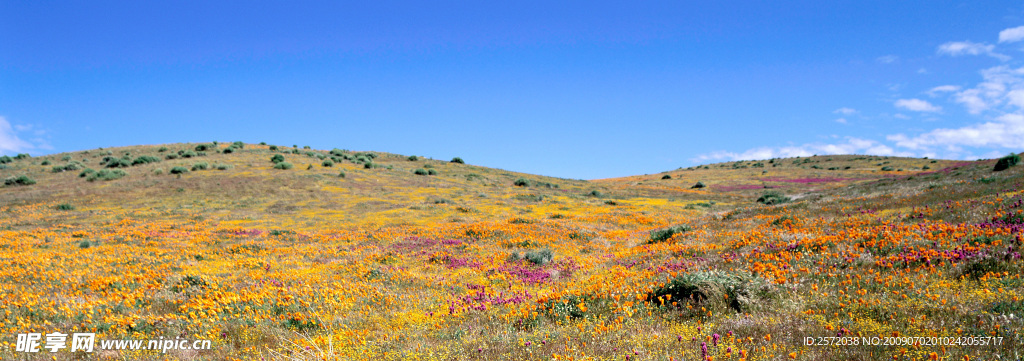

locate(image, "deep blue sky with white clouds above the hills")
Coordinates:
0 1 1024 179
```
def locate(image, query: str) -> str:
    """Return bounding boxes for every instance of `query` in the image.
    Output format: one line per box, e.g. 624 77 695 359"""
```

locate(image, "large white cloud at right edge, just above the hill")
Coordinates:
886 114 1024 151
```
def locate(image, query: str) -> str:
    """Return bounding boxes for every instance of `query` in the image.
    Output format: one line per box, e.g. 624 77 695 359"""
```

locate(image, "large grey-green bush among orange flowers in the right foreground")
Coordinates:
647 271 774 312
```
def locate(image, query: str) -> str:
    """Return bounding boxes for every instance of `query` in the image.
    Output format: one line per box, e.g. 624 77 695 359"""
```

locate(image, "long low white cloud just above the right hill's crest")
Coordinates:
694 137 913 162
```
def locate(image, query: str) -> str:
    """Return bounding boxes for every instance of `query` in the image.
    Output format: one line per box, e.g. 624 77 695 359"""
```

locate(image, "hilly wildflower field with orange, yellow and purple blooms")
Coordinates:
0 142 1024 360
